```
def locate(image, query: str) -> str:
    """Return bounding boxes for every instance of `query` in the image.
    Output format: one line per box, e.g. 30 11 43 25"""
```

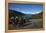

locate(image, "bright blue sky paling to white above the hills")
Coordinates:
8 3 43 14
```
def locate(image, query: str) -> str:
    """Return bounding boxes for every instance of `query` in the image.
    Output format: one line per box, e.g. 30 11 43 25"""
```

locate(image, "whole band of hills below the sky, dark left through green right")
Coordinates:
9 9 43 19
